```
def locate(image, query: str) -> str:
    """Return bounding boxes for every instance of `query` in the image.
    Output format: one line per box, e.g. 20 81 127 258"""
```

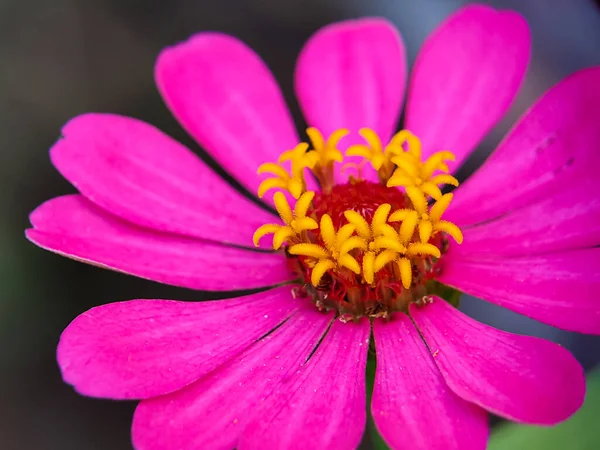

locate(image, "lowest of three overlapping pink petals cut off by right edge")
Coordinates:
438 246 600 334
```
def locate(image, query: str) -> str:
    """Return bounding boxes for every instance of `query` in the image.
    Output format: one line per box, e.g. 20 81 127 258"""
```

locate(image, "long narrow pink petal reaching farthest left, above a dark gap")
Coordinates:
26 195 294 291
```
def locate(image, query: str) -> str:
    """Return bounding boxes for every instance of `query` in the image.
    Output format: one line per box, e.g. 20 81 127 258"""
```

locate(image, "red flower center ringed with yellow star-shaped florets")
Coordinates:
254 128 462 318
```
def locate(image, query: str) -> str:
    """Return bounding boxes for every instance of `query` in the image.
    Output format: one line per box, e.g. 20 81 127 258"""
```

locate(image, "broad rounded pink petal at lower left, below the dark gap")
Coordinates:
57 287 298 399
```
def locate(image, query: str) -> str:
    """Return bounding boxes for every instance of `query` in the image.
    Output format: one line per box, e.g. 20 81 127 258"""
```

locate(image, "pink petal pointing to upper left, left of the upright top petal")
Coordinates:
155 33 299 204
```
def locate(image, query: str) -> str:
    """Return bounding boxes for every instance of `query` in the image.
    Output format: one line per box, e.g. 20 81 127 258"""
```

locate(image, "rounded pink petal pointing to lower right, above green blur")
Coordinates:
410 297 585 425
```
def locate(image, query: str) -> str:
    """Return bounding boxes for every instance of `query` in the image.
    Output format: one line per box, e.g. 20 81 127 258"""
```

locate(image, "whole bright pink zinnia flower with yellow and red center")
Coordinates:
27 6 600 449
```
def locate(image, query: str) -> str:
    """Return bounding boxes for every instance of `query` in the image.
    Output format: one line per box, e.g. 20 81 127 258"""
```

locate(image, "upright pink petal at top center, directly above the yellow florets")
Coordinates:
295 18 406 182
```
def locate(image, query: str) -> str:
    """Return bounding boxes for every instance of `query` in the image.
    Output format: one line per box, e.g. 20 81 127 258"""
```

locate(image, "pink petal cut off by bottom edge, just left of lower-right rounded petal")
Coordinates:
371 313 488 450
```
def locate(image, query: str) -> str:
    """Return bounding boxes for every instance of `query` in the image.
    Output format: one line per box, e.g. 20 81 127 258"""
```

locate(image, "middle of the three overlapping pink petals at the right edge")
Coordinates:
459 178 600 257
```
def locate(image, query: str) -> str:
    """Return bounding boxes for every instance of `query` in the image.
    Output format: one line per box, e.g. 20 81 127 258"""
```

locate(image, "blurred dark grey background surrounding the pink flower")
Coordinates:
0 0 600 450
